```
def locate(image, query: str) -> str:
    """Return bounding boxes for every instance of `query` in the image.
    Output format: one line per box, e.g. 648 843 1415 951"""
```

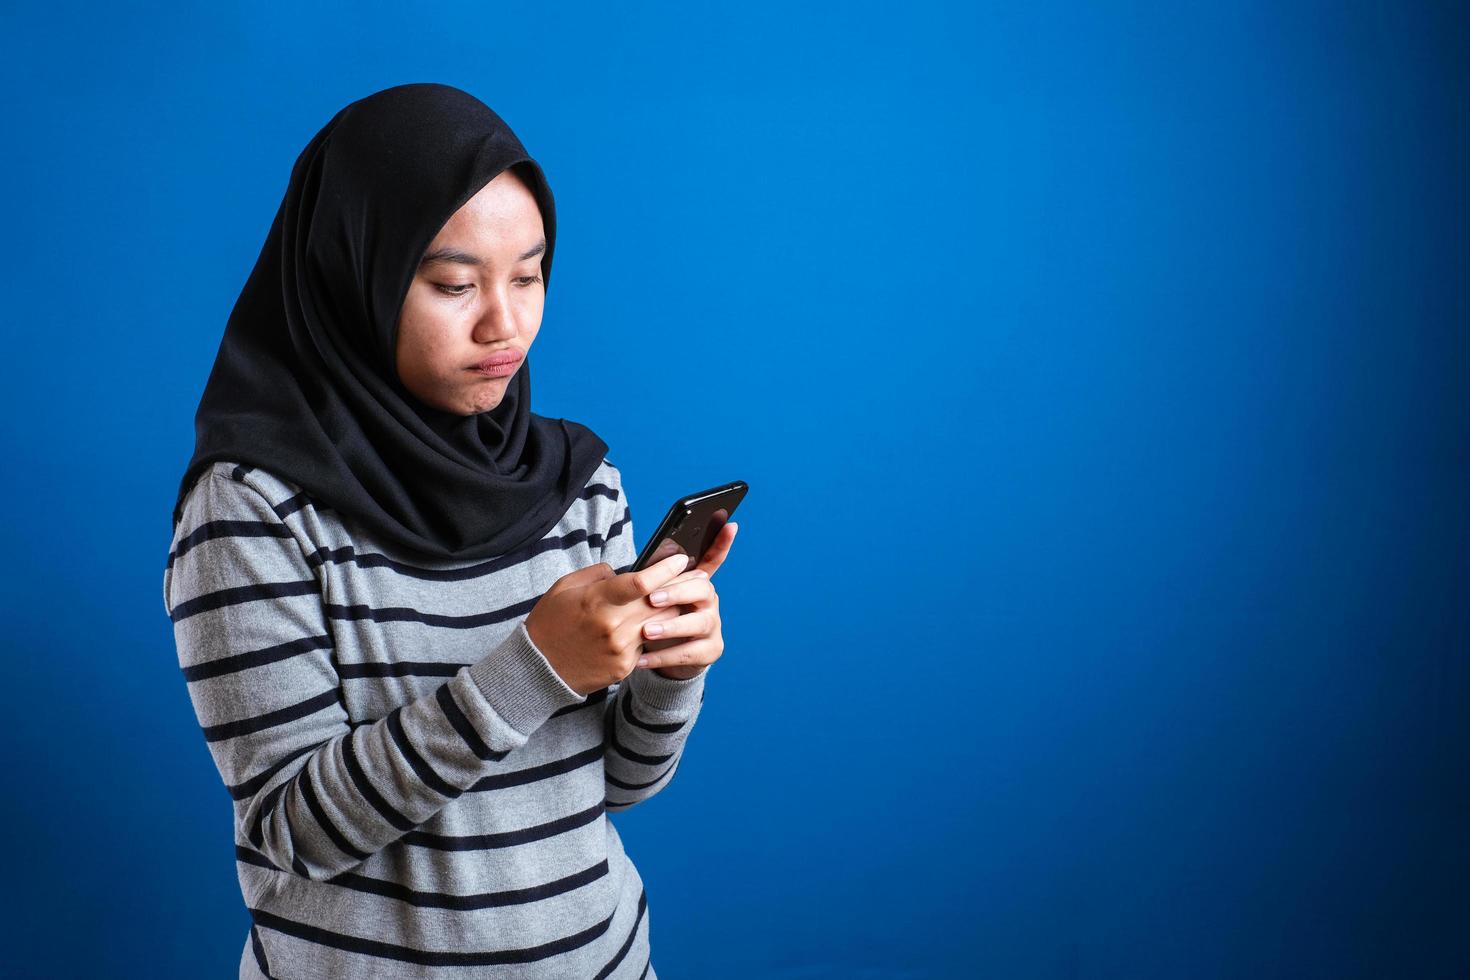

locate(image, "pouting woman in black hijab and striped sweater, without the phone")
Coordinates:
163 84 735 979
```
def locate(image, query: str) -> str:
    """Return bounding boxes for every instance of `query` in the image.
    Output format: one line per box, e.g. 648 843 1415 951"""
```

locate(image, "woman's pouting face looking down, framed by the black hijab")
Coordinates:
395 170 545 416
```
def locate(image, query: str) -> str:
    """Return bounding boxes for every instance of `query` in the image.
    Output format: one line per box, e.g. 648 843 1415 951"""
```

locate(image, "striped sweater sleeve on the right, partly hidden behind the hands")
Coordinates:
603 469 709 811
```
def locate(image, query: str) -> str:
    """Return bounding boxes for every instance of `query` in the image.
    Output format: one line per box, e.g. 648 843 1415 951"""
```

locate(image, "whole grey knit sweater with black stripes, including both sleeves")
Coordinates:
163 460 707 980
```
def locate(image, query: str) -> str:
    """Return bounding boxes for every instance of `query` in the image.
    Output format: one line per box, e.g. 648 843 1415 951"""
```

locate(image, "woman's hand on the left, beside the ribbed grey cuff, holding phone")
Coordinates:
526 552 711 696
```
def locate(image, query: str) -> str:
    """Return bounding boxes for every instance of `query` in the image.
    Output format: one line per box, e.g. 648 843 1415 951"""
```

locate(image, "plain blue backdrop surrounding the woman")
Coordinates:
0 1 1470 980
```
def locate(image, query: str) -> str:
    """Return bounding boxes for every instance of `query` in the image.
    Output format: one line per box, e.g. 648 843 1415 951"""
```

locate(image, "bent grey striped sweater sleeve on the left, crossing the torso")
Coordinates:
163 470 585 880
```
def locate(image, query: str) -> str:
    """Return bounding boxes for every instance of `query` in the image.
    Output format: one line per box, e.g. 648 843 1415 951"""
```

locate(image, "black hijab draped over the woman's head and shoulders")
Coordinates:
173 82 607 558
